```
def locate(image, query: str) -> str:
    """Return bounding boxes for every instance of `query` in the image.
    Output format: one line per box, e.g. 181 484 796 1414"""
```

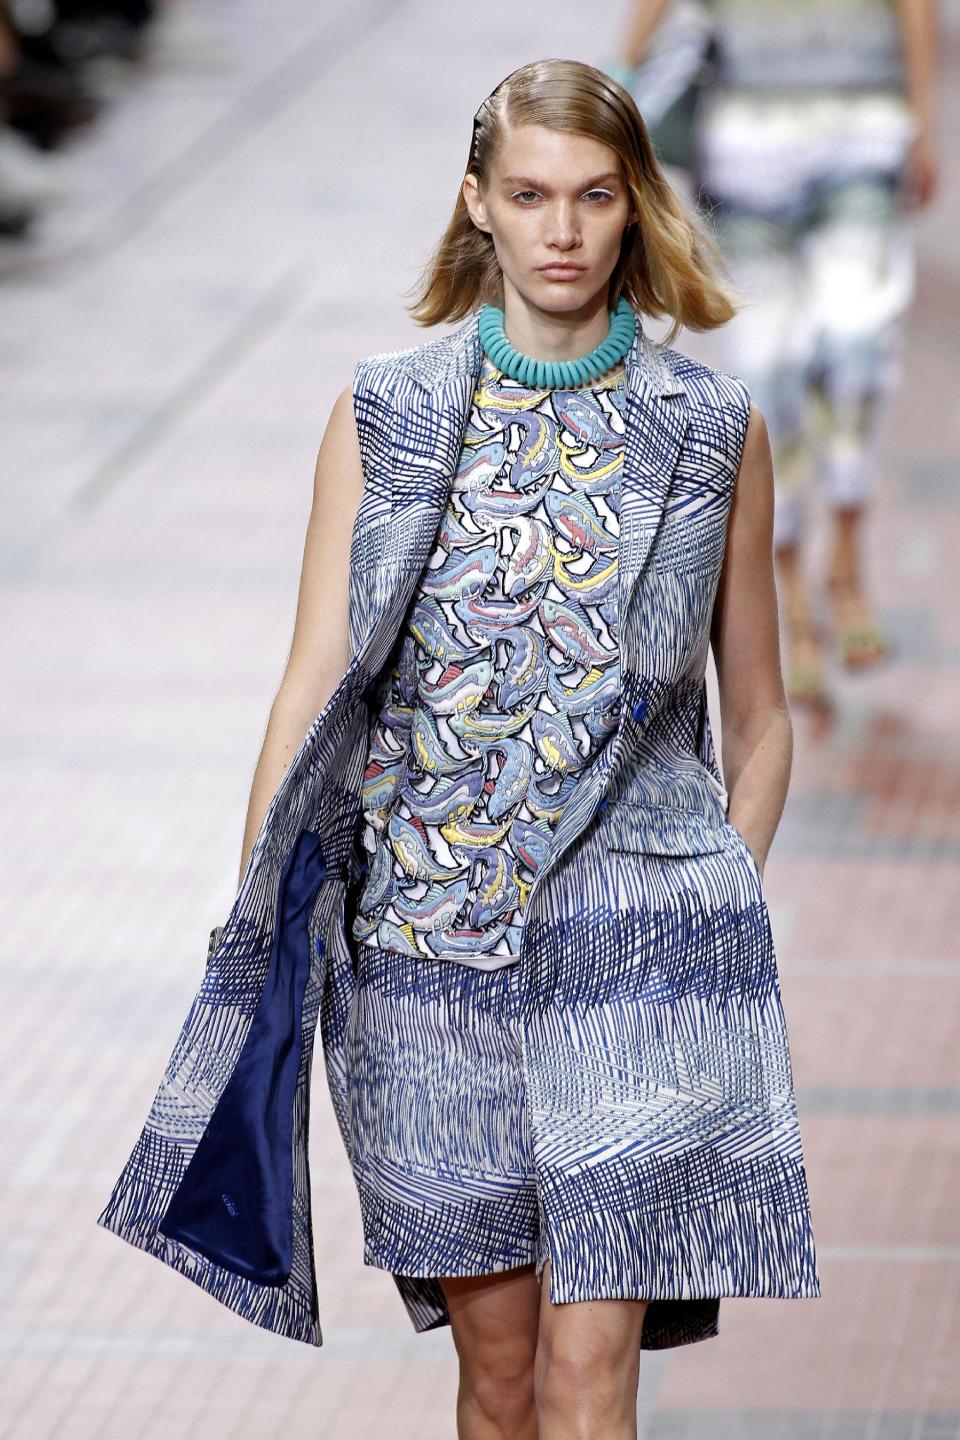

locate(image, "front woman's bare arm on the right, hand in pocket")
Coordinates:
711 405 793 873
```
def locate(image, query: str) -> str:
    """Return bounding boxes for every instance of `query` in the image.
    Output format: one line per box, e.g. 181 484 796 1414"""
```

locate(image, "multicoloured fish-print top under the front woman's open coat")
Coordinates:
351 356 626 969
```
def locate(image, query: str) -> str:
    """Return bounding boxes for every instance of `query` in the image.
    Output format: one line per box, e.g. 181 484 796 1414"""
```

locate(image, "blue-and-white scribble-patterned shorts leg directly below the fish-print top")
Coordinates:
350 945 547 1276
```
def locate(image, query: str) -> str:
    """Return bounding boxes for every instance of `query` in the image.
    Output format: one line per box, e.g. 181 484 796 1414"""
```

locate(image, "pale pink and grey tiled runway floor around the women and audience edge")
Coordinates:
0 0 960 1440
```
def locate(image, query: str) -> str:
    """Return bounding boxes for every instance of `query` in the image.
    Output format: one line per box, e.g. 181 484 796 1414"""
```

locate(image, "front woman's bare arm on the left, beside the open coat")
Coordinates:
239 386 364 881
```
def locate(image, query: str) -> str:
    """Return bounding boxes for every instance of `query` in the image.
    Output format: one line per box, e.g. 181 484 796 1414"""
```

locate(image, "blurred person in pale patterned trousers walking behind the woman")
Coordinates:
607 0 937 707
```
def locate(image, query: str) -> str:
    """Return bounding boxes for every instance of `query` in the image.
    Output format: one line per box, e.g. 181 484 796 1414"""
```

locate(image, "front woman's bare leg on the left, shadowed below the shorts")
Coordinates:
440 1264 540 1440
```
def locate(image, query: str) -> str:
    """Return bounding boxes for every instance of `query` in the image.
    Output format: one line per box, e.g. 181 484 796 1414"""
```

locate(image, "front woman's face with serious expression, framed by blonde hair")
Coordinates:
463 125 632 312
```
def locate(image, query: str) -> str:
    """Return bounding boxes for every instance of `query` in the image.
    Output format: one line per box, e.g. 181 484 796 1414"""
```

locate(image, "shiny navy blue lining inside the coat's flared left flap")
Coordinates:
158 831 327 1284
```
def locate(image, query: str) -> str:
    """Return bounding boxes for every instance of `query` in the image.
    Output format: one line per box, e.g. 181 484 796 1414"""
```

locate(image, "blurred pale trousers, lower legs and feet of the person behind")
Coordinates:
699 92 914 706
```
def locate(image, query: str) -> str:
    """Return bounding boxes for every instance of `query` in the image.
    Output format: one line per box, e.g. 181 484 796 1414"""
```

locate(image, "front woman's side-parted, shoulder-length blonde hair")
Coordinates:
407 59 740 344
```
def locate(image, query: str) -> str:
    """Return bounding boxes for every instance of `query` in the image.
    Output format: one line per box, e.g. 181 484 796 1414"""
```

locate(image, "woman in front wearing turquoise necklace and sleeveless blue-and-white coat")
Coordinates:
99 59 820 1440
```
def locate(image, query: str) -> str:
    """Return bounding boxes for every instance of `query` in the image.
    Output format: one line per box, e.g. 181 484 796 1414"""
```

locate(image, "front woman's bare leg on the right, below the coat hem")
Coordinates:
534 1260 646 1440
